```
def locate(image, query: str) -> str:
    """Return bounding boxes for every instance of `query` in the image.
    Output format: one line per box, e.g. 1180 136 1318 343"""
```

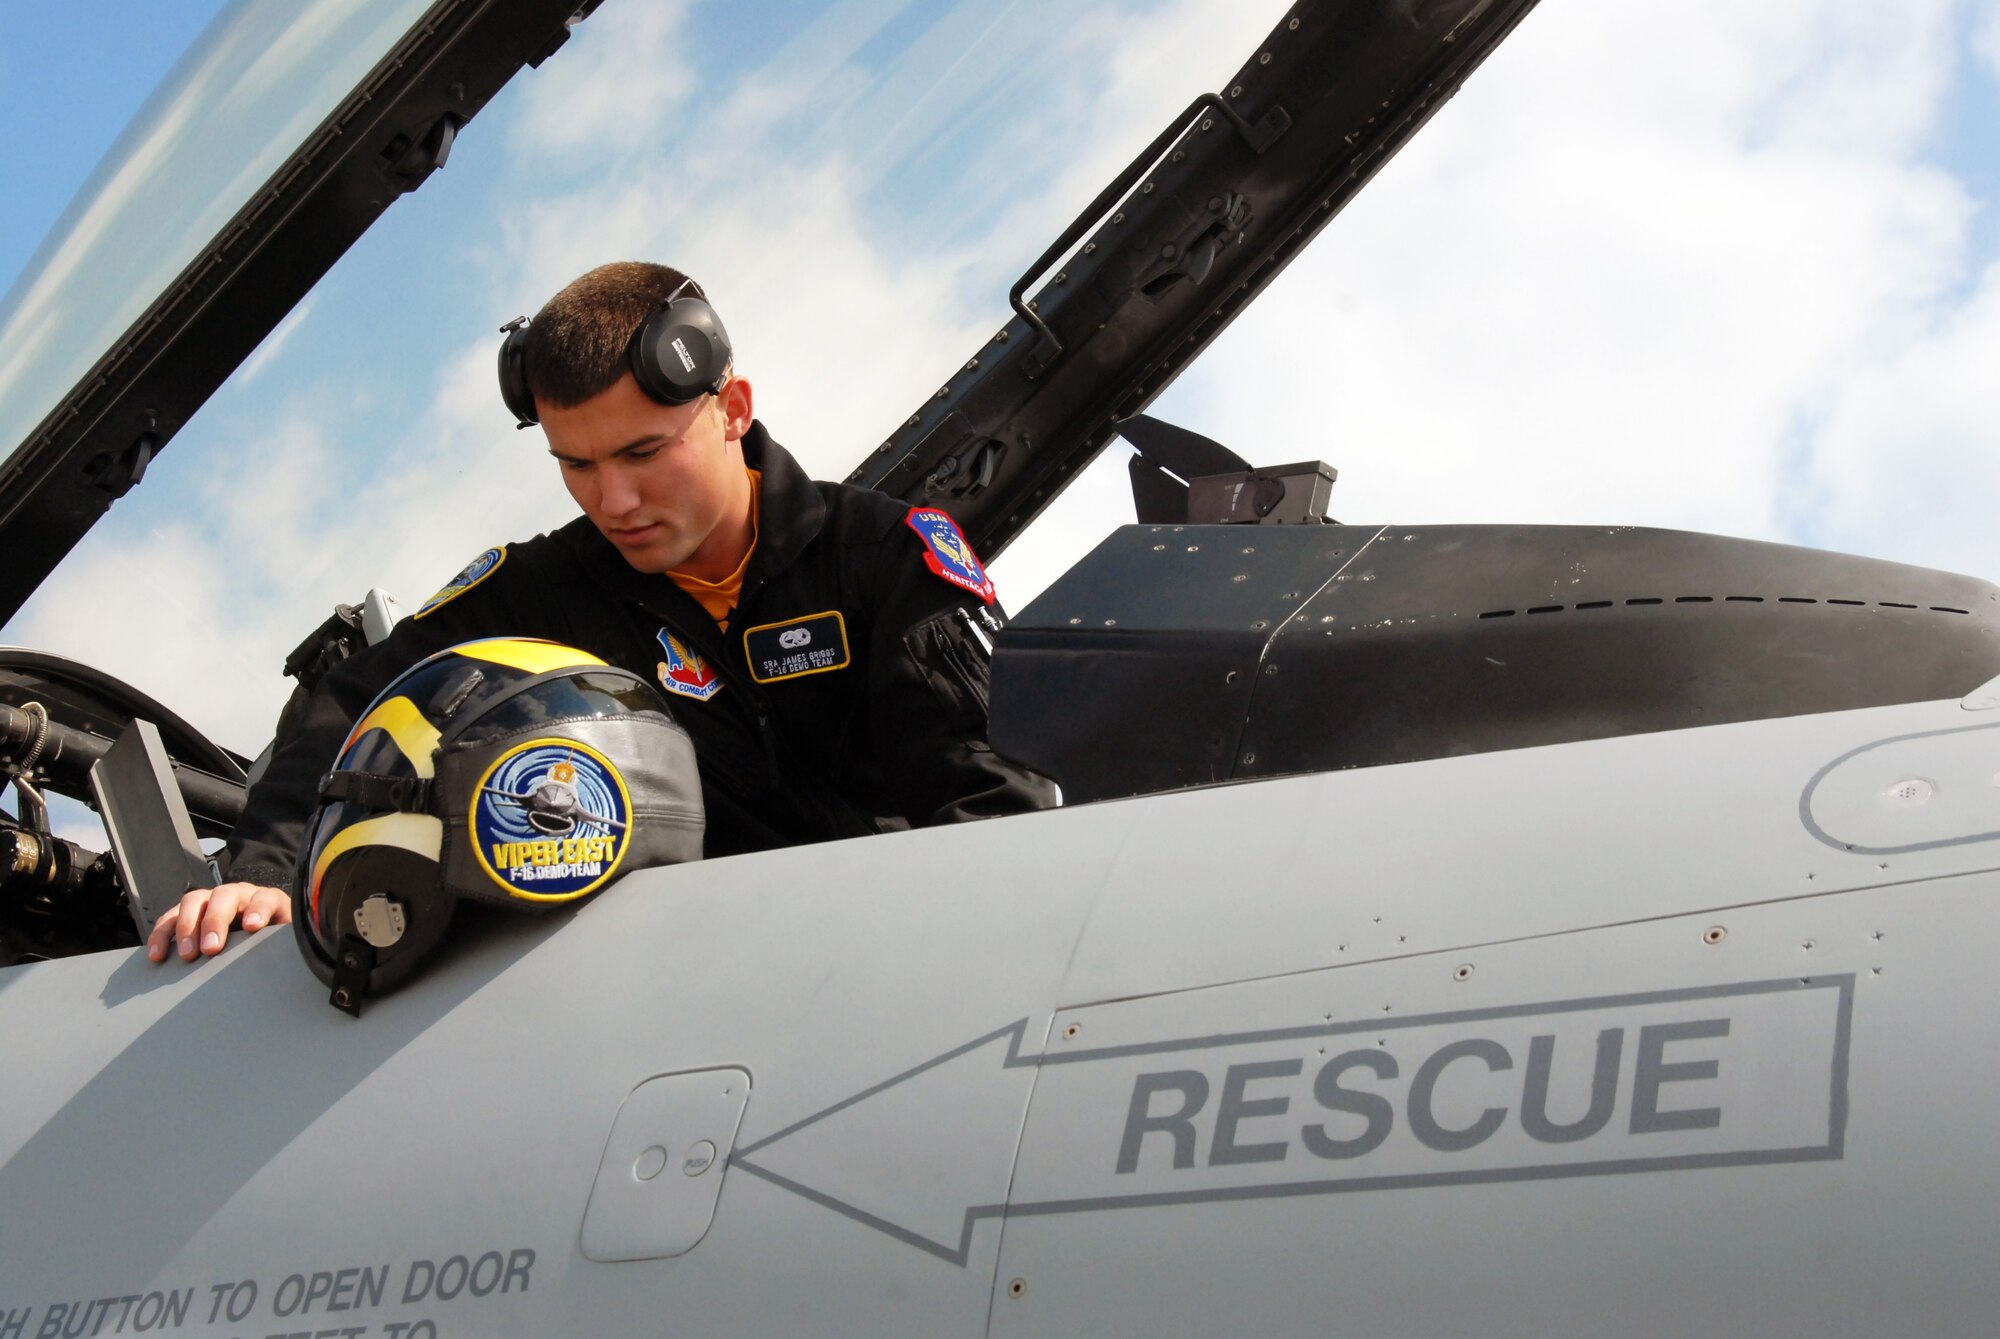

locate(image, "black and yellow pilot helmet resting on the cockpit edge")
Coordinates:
292 638 704 1013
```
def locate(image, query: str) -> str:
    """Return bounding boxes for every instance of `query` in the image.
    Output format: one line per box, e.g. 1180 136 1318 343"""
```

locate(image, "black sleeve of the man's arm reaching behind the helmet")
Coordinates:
228 550 574 889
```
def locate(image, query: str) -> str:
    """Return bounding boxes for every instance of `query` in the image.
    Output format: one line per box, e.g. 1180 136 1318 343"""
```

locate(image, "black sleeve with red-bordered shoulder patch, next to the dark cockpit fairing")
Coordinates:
870 536 1062 827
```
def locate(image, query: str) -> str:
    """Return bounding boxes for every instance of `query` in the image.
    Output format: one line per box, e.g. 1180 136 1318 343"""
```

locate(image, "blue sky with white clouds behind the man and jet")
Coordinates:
0 0 2000 767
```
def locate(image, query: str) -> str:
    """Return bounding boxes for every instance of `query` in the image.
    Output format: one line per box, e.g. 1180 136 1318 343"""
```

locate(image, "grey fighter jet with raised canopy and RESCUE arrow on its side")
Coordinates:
0 0 2000 1339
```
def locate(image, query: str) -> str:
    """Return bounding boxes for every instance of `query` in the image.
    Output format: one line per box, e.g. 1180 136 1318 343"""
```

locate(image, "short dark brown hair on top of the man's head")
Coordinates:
524 260 708 410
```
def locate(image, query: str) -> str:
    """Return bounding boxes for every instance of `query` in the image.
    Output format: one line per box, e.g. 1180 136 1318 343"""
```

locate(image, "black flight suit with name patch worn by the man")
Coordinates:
230 424 1056 887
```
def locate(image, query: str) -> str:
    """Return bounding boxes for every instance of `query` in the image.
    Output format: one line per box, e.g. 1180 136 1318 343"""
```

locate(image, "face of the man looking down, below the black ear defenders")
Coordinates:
538 374 750 576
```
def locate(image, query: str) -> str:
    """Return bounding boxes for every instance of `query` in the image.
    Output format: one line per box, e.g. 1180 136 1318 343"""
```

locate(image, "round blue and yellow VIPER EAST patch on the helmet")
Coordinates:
470 739 632 901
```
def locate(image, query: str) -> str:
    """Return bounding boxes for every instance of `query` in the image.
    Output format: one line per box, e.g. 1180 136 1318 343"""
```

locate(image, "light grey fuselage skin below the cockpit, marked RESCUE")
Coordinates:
0 2 2000 1339
